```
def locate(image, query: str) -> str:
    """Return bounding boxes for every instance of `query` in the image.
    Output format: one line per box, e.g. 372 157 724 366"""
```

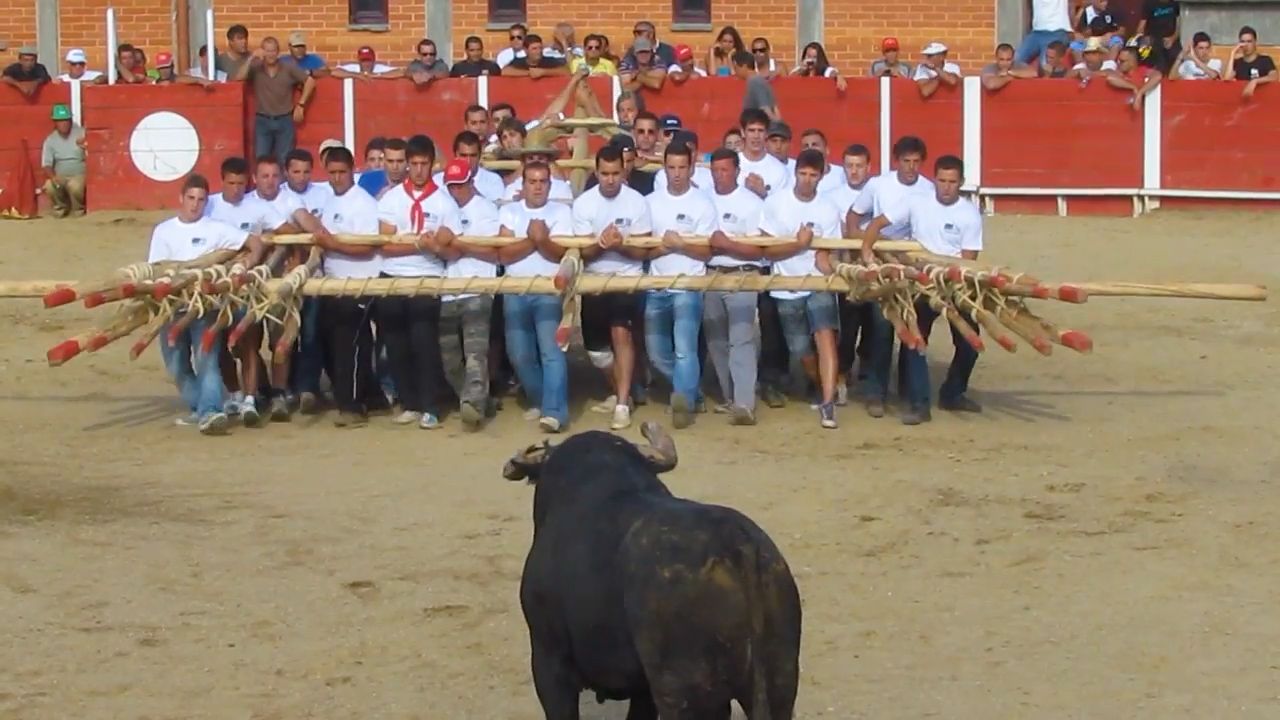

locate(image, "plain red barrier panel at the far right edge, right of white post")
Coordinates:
1160 82 1280 192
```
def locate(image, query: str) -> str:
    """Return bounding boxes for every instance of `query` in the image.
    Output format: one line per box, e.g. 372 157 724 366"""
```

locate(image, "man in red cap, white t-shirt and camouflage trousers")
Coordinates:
440 157 499 430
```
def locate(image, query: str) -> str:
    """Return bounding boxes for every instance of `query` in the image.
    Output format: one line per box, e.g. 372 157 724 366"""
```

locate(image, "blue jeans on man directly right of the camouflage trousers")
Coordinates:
502 295 568 428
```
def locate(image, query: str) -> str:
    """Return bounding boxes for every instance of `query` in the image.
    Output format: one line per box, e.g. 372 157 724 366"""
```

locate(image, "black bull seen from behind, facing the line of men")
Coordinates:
503 423 800 720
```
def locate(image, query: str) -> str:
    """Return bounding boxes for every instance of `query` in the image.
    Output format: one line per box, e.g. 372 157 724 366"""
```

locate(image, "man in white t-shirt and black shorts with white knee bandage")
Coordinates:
573 145 653 430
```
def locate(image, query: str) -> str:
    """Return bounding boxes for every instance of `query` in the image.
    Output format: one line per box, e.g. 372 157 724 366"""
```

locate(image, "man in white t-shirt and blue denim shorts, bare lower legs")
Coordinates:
760 149 841 428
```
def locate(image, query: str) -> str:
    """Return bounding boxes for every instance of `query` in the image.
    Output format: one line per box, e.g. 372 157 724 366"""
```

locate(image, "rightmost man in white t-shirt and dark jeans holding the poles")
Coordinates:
863 155 982 425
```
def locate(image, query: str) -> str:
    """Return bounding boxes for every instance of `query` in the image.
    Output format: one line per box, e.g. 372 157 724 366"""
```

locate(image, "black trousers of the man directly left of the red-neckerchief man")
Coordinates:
320 297 378 415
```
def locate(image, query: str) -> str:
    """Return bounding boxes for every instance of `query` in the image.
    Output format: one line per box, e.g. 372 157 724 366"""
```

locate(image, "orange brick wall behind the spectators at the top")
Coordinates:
0 0 995 74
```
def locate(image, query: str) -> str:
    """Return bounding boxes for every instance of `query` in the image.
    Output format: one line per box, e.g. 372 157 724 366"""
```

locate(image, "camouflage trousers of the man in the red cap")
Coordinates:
440 295 493 411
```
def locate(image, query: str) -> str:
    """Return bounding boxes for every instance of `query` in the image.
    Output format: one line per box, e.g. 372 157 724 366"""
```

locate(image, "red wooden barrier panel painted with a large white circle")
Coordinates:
82 85 244 210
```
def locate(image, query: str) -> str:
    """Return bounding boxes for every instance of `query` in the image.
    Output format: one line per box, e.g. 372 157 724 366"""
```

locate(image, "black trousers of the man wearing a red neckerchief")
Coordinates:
378 296 448 416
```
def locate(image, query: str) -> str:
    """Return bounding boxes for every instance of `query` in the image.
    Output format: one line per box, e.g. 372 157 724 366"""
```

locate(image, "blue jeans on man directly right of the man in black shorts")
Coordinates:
644 290 703 405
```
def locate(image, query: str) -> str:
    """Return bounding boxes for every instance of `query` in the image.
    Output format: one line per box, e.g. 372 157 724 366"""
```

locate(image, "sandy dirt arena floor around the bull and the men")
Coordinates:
0 213 1280 720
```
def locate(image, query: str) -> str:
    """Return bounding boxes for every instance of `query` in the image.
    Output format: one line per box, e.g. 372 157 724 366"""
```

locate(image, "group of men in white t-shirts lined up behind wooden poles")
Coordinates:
151 110 982 433
